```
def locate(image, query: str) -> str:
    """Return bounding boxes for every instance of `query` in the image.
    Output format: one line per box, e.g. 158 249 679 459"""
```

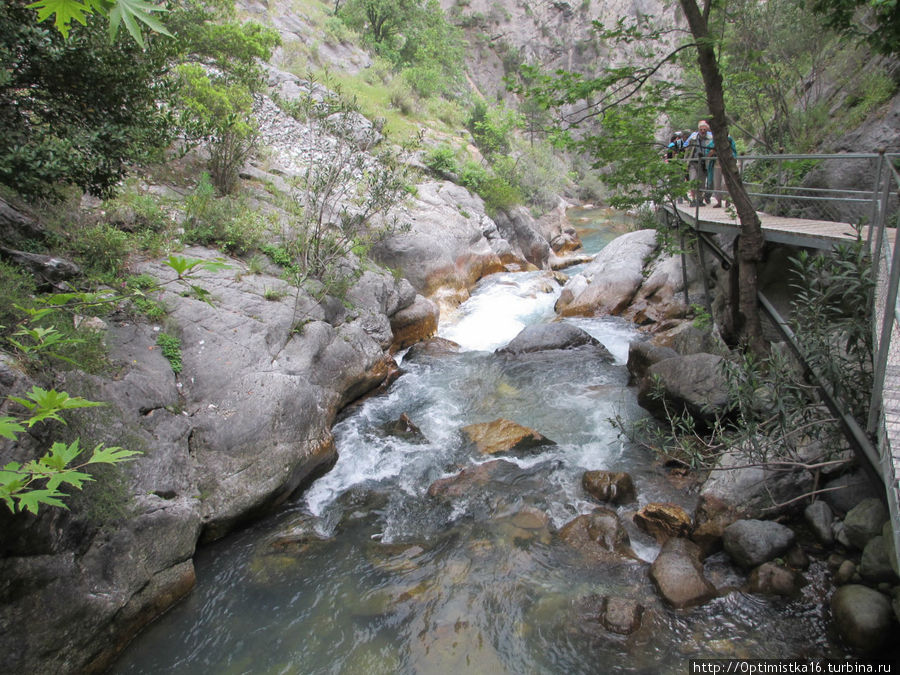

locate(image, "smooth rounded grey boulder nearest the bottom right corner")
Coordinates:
831 584 893 652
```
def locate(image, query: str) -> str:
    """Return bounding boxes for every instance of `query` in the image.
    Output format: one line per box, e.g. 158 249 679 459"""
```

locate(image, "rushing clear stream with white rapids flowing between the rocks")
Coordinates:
114 211 834 675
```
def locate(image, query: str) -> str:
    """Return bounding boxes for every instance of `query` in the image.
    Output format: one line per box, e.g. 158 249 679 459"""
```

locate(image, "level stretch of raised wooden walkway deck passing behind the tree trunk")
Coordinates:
665 204 867 250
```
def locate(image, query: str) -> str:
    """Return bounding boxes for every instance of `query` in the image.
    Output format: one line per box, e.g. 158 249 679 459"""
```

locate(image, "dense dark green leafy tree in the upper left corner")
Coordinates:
0 0 175 199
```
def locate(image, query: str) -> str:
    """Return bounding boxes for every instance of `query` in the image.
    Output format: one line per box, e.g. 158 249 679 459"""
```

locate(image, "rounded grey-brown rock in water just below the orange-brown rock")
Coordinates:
650 539 716 609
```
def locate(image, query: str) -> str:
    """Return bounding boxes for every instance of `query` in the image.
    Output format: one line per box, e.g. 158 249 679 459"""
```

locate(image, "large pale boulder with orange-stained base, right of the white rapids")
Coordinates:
557 230 656 316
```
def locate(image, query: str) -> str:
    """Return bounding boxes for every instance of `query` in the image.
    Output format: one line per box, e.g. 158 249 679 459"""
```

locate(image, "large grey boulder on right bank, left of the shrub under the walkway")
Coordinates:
638 354 728 422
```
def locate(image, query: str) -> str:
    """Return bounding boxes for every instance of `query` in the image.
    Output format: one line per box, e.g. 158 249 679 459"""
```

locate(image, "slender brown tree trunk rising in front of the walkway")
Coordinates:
680 0 766 354
